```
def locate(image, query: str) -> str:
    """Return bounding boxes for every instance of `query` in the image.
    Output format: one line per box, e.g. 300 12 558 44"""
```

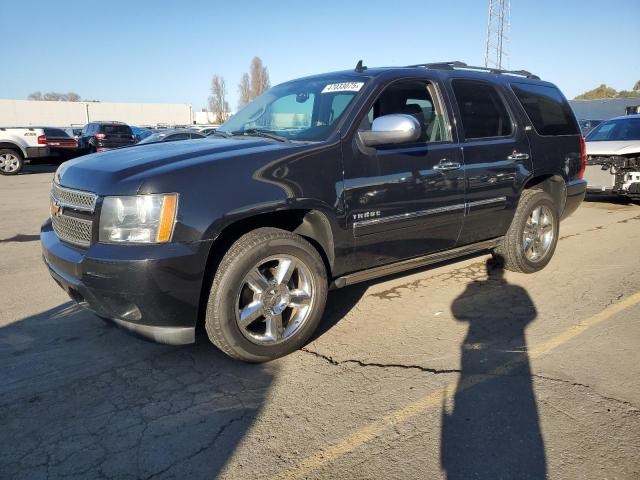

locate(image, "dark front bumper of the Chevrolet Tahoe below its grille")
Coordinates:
40 220 211 345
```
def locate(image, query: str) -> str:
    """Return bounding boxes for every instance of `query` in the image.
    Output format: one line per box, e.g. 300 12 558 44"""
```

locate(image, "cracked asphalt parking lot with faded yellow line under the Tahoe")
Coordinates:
0 166 640 479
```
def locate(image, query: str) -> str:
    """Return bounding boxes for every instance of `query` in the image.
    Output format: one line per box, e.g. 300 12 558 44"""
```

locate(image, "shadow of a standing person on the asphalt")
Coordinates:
441 260 547 480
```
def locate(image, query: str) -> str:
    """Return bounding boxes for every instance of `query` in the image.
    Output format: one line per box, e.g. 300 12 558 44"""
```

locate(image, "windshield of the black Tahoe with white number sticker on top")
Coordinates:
217 77 366 141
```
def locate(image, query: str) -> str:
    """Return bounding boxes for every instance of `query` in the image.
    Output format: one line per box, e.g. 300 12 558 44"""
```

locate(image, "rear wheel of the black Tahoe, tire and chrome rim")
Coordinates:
493 189 560 273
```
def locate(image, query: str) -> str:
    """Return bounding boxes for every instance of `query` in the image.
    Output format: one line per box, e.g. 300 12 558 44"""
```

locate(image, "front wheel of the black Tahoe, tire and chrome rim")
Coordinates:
205 228 328 362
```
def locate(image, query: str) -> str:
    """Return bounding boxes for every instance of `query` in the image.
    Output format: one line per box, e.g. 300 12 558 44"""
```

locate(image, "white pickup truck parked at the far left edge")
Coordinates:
0 127 49 175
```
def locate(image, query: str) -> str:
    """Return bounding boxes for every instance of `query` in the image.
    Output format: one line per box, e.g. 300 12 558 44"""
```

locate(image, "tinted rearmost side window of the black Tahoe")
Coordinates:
511 83 580 136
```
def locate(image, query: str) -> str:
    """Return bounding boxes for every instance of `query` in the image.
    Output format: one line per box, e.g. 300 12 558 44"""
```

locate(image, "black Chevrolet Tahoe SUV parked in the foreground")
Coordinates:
41 62 586 362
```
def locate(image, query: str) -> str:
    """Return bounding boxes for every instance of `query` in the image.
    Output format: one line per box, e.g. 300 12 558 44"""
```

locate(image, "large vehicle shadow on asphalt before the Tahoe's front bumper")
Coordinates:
0 302 277 479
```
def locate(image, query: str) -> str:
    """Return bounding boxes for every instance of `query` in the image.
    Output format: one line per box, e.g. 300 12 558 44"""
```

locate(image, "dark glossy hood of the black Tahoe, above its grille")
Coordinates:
55 138 301 195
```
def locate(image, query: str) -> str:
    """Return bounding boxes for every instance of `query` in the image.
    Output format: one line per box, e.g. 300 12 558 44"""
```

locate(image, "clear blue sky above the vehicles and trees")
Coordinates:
0 0 640 111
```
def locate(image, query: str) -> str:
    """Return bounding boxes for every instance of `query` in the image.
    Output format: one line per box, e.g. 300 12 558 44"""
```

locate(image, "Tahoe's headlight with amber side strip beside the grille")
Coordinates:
99 193 178 243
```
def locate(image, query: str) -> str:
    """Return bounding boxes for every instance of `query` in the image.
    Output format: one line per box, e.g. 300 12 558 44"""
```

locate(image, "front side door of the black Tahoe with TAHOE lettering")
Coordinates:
344 80 464 269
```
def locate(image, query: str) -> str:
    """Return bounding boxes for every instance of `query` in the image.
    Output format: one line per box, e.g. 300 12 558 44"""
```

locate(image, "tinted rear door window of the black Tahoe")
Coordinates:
452 80 513 140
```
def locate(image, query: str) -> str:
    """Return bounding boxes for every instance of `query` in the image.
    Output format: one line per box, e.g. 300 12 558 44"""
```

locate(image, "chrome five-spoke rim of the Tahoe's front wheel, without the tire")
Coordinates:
235 255 314 345
